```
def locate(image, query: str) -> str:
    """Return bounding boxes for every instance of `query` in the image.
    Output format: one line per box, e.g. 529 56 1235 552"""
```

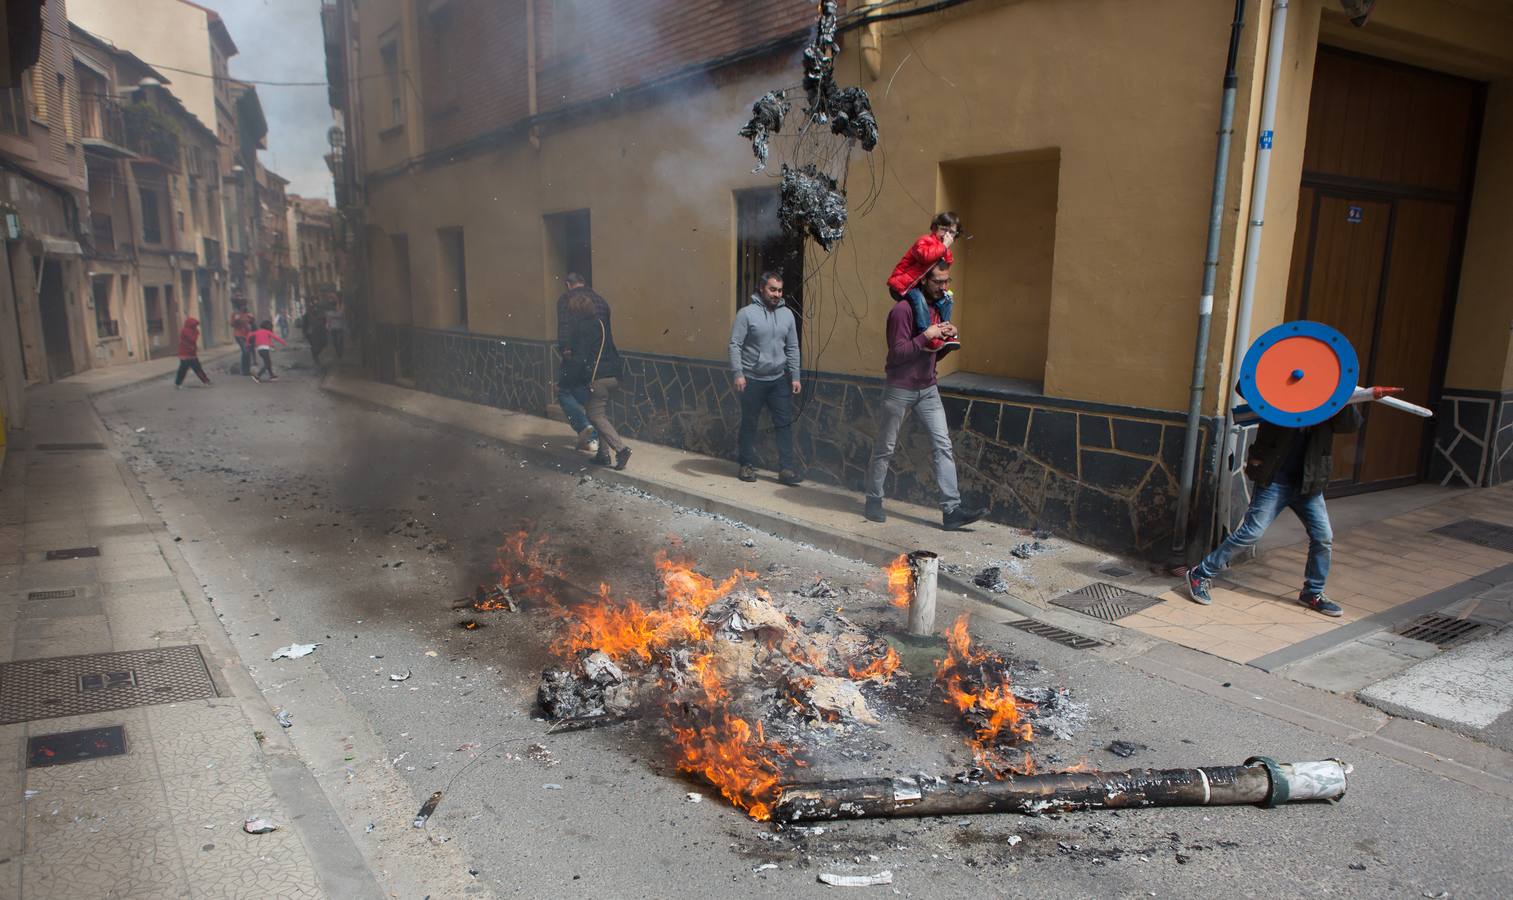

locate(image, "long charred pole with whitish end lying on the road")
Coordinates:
773 756 1351 823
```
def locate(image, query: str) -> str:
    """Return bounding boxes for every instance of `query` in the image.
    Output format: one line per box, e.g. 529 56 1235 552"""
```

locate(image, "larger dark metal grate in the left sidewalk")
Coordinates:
0 646 216 725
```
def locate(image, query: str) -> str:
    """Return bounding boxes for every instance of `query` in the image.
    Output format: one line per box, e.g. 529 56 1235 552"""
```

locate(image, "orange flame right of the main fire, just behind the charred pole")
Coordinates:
935 613 1035 777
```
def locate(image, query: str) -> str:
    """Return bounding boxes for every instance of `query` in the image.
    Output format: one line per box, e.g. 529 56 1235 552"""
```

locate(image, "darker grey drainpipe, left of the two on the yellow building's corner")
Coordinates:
1171 0 1245 554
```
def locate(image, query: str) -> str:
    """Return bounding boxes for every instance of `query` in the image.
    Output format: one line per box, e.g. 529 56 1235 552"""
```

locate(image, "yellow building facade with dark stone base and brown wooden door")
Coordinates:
331 0 1513 557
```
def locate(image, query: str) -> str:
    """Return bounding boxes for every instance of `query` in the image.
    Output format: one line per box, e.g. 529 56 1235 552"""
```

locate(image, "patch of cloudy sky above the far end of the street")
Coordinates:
198 0 334 200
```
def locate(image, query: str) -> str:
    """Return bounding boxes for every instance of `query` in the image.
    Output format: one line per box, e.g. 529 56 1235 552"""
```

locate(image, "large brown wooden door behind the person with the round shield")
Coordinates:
1288 47 1481 493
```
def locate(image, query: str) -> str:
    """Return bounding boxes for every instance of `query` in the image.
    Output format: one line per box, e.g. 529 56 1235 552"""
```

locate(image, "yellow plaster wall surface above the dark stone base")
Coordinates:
362 0 1513 414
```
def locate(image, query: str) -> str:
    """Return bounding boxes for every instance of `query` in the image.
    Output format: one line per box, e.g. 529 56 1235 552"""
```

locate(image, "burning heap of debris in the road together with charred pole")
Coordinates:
471 531 1348 821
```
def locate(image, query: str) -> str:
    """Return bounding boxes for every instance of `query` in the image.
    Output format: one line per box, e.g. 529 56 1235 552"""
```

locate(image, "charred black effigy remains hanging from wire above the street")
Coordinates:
740 0 878 251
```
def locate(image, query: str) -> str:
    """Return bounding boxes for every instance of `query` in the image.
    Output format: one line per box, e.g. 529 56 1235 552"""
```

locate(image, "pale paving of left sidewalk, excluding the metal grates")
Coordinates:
0 350 340 897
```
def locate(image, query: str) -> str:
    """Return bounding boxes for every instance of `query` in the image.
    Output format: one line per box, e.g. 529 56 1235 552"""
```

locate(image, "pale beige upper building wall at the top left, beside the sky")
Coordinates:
68 0 217 132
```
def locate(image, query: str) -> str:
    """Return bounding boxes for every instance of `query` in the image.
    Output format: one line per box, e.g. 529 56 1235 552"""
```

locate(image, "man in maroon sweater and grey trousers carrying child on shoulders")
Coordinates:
864 262 982 531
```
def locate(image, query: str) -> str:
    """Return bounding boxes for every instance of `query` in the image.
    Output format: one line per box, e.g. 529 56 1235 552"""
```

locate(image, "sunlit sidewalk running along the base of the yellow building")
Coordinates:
324 372 1513 685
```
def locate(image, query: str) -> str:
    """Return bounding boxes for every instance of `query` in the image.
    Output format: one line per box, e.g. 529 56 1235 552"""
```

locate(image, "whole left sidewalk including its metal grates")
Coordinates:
0 348 381 897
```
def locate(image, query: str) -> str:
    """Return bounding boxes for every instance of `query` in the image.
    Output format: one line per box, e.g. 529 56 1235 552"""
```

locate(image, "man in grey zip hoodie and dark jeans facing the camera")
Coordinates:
731 272 803 484
